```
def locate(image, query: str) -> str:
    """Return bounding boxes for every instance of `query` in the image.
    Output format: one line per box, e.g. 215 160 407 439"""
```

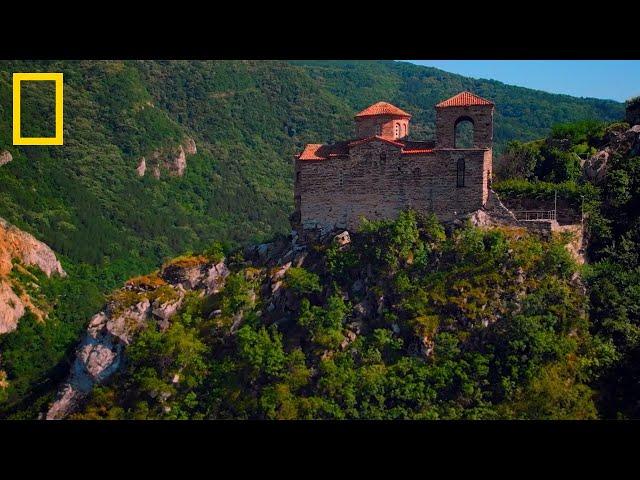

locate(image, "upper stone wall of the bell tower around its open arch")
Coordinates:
436 105 493 148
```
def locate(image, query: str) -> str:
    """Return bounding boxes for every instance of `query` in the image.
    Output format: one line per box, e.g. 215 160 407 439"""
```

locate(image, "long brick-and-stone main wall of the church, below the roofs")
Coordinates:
294 140 491 232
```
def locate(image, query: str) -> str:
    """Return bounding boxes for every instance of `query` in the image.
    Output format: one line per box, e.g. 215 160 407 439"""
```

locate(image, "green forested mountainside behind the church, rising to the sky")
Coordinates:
0 61 623 416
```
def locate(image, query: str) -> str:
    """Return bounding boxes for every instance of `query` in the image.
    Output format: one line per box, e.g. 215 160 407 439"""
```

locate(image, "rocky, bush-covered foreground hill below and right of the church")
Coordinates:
35 106 640 419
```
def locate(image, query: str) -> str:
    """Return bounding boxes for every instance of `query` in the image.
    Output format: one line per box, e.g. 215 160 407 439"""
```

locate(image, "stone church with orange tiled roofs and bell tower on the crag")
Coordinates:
292 92 494 234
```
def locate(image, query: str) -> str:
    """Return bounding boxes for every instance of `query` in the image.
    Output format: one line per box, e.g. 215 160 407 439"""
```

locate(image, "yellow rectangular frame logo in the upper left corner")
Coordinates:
13 73 63 145
